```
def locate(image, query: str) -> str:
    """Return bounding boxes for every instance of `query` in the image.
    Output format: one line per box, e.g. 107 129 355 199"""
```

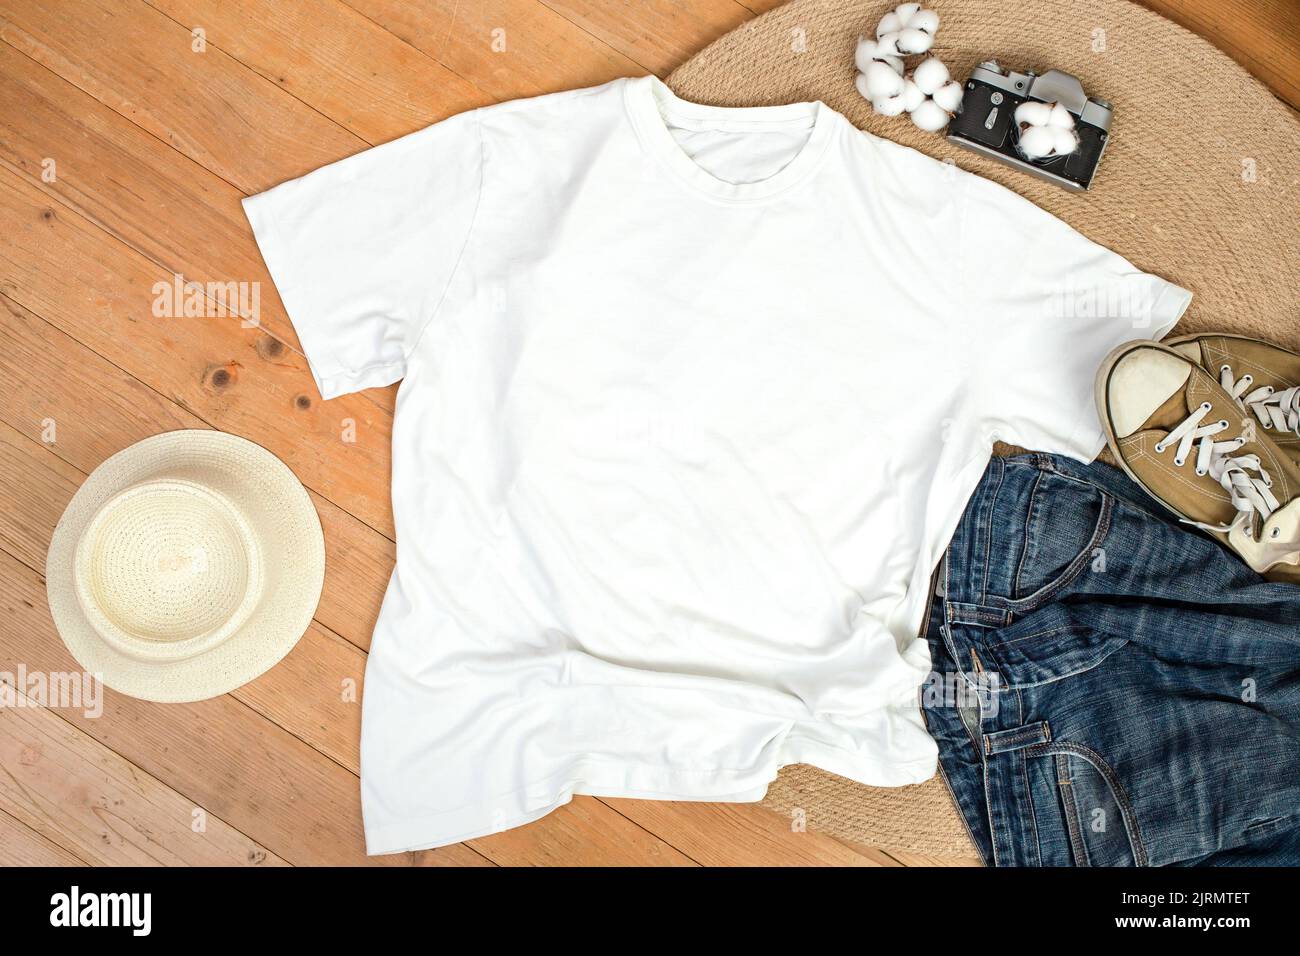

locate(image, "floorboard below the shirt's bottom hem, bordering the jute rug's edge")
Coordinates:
605 797 900 866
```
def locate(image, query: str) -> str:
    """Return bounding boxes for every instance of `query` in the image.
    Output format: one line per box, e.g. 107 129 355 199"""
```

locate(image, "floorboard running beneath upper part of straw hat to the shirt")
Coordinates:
0 295 394 649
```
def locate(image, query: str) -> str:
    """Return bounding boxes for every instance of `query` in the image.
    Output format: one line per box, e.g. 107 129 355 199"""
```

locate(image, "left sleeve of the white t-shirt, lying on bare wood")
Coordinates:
243 111 484 398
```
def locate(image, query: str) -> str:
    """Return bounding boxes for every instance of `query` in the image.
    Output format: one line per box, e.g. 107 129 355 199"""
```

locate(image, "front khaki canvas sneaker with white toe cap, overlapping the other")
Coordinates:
1096 339 1300 583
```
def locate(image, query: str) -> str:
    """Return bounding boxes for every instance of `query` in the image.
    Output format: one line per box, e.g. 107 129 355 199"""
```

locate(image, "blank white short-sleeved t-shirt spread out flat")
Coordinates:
244 78 1191 853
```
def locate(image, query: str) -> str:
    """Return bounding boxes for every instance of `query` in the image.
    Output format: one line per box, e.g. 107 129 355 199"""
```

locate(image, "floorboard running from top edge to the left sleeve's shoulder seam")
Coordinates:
146 0 491 143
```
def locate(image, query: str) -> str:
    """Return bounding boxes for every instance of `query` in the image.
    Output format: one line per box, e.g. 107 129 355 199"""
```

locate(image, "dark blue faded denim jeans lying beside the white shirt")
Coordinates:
922 454 1300 866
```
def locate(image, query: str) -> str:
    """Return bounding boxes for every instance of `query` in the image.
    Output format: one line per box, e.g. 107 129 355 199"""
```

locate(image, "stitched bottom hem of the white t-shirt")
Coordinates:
365 736 939 856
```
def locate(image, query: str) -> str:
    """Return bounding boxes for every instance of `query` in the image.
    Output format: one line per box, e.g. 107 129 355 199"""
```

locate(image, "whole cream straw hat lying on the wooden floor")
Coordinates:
46 429 325 702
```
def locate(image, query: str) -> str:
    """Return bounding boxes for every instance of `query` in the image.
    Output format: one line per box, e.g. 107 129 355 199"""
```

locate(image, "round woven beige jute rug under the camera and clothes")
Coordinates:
668 0 1300 857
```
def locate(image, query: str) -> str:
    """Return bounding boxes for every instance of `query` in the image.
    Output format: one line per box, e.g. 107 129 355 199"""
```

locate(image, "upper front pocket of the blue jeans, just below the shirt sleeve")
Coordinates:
1009 470 1114 611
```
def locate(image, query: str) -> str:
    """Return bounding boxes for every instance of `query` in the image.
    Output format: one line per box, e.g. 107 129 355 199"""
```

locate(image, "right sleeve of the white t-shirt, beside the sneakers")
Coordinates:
954 176 1192 462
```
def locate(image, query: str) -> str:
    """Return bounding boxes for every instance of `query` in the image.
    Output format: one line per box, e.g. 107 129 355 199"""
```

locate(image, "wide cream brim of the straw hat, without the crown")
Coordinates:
46 429 325 702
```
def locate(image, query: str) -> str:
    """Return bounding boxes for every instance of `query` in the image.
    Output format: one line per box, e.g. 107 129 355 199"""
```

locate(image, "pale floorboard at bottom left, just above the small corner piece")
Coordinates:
0 684 285 866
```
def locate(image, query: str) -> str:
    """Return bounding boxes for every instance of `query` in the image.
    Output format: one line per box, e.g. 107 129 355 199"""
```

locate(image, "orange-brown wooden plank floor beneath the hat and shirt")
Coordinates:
0 0 1300 866
